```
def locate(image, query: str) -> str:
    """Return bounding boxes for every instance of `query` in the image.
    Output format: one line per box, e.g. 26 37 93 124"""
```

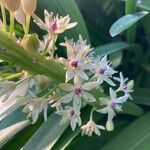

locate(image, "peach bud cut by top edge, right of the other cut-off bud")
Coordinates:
21 0 37 16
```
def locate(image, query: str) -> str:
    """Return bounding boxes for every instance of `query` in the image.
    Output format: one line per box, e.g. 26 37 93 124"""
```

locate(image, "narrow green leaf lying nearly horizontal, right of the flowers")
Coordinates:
93 42 136 57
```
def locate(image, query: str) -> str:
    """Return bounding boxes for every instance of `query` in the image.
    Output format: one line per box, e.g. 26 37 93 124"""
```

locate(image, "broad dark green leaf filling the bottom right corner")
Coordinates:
100 112 150 150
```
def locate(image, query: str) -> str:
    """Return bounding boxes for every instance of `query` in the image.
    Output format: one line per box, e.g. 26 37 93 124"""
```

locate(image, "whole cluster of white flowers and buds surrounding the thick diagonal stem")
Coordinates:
0 0 134 136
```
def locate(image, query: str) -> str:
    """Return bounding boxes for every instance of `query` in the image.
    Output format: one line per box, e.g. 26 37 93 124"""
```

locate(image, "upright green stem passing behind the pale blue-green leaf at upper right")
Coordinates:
125 0 137 43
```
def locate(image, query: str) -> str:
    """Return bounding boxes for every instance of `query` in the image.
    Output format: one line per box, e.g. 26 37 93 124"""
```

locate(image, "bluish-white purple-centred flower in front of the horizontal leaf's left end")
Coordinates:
94 56 116 86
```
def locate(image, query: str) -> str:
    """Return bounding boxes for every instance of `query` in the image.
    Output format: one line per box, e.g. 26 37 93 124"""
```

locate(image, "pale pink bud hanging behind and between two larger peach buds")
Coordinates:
15 7 26 26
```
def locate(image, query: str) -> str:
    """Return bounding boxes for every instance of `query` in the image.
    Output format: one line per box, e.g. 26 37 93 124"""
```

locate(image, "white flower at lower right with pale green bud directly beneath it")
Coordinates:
97 88 128 131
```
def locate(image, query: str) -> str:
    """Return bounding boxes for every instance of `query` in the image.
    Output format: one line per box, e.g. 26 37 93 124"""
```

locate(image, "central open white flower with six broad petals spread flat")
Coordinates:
60 79 99 108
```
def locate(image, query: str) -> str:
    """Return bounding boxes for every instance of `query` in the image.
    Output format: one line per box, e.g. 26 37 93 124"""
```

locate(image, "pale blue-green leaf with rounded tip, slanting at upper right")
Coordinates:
109 11 148 37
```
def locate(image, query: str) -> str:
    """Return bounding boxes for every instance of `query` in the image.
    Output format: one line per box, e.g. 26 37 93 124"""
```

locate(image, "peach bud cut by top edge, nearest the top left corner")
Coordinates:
3 0 21 12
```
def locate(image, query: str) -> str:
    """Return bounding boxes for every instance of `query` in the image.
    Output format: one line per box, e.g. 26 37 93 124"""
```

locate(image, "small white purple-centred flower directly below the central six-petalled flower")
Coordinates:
56 106 82 131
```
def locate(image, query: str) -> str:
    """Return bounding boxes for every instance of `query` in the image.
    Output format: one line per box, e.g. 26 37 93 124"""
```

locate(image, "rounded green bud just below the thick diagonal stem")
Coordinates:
34 75 50 90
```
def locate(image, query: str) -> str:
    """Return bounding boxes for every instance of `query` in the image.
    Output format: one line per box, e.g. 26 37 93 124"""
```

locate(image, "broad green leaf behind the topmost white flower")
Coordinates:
37 0 90 41
